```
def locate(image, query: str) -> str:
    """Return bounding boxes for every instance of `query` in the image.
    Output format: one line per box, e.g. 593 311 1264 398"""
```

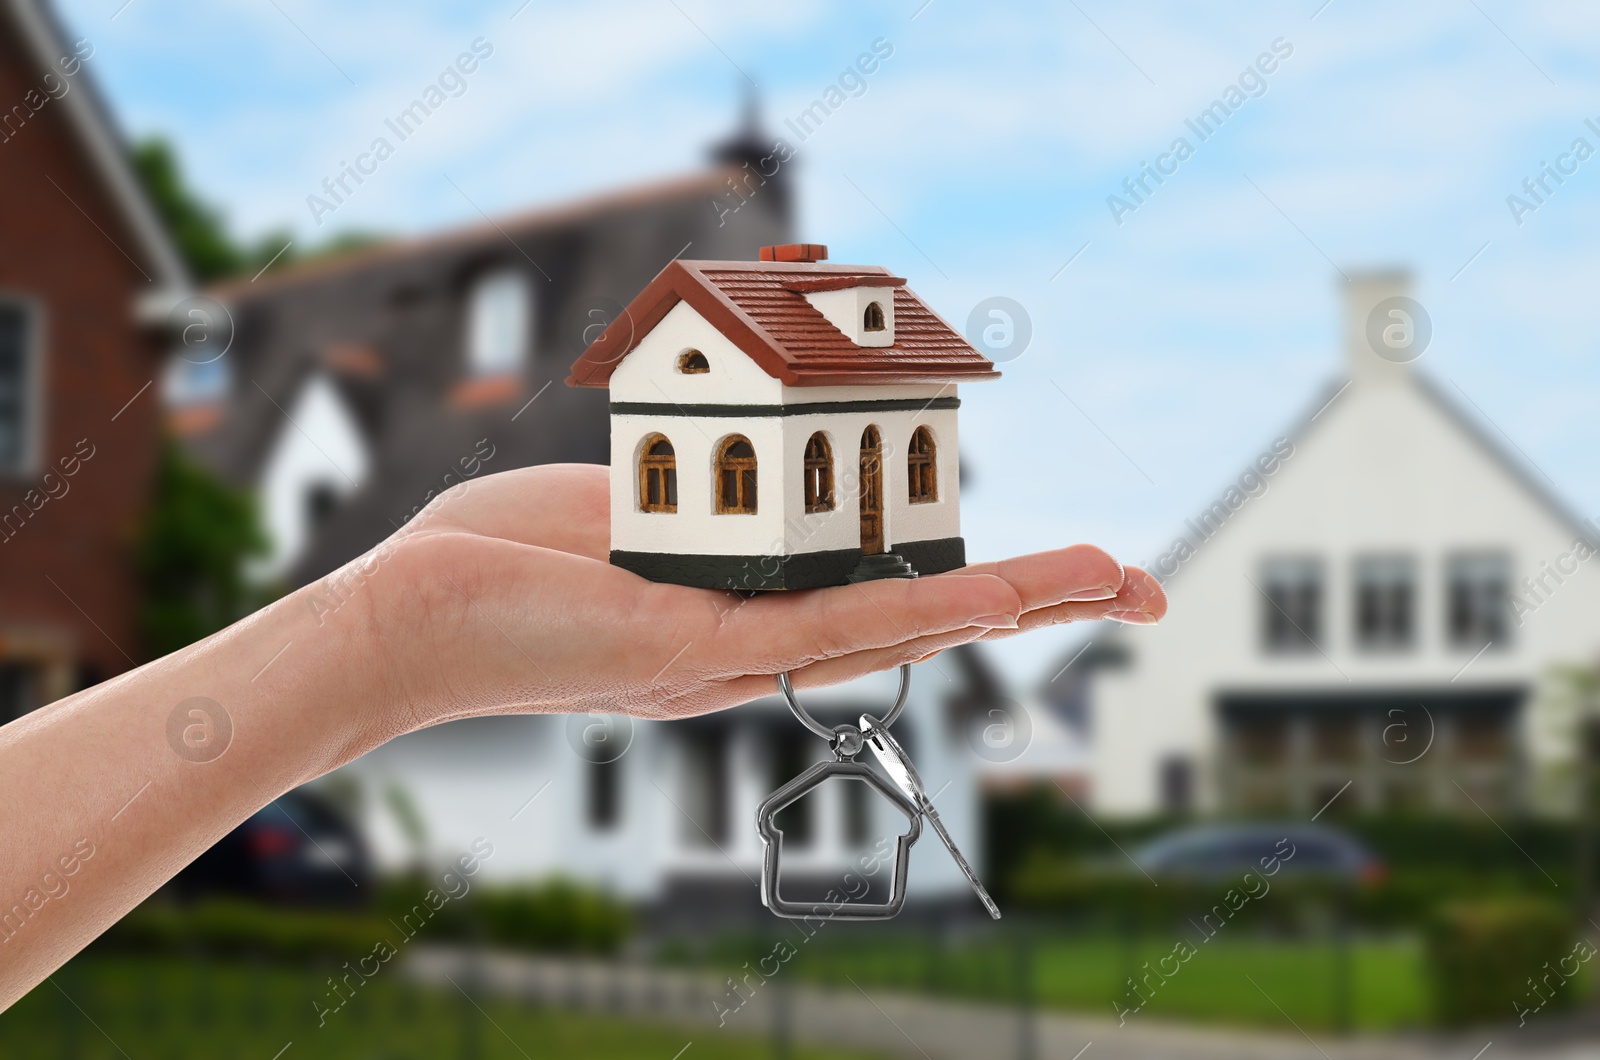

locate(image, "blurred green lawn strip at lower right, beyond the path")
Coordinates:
768 934 1429 1031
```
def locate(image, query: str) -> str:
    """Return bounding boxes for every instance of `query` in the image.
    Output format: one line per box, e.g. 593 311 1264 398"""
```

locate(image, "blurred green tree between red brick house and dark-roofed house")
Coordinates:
136 439 274 656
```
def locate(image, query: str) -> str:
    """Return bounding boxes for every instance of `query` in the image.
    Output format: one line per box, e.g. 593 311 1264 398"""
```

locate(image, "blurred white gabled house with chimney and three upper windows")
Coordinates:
1053 274 1600 815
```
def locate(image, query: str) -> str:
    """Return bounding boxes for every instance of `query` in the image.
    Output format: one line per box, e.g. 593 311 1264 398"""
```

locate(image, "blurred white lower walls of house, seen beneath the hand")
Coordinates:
348 648 998 925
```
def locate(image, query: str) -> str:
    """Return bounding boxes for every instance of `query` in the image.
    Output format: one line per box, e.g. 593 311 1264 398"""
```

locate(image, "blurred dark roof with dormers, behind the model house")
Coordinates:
178 112 790 584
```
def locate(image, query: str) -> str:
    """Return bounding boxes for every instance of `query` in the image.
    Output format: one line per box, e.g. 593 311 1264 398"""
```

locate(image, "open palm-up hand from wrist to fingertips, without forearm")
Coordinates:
337 464 1166 738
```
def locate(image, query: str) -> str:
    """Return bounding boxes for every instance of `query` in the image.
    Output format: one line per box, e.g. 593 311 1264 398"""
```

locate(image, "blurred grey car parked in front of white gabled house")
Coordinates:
1133 825 1384 884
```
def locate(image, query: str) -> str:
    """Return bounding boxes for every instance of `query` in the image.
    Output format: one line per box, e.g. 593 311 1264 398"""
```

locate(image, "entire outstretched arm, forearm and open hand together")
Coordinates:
0 464 1166 1009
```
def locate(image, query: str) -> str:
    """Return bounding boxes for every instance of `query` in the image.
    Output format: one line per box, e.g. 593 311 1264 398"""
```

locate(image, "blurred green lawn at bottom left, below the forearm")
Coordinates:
0 956 889 1060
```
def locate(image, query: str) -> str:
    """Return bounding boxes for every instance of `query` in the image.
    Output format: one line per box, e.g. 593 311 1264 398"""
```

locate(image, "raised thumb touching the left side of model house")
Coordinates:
408 464 611 559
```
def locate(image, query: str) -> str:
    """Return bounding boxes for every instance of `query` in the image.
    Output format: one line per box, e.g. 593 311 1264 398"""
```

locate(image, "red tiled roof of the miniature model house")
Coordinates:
566 261 1000 386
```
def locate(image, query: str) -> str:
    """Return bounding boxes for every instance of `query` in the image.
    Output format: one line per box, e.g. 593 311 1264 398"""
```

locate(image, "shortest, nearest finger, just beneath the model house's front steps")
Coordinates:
717 572 1022 674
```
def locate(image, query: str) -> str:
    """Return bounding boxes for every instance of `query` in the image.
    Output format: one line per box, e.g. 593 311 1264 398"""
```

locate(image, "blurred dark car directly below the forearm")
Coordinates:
174 789 373 906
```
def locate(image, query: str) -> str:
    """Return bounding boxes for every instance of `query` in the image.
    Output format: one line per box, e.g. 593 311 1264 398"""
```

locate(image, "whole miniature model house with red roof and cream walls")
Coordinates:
568 243 1000 589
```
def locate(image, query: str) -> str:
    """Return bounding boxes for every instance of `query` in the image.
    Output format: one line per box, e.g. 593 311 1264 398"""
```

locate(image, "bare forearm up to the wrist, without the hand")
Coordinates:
0 576 392 1009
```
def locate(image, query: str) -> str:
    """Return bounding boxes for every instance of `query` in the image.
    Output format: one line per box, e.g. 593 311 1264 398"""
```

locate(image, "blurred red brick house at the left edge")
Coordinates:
0 0 187 724
